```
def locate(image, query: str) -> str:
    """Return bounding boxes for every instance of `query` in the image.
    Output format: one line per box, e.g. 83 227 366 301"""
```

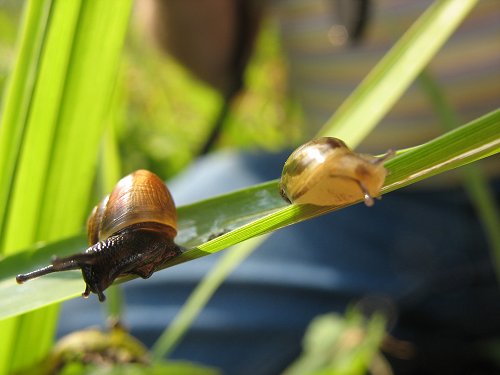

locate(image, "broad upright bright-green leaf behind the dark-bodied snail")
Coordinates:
0 0 131 373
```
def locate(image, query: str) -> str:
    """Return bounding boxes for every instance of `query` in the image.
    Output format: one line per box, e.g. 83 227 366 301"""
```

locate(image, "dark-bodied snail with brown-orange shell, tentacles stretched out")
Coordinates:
16 170 182 302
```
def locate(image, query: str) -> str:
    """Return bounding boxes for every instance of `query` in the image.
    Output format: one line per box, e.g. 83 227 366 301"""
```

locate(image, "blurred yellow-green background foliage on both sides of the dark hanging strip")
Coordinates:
118 15 301 176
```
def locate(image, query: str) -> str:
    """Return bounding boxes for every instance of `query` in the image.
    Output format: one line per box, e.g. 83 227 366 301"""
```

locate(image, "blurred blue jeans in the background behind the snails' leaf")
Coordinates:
59 151 500 375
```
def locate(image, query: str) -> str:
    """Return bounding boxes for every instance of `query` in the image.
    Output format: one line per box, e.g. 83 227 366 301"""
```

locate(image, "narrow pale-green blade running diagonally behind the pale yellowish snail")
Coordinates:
153 0 484 359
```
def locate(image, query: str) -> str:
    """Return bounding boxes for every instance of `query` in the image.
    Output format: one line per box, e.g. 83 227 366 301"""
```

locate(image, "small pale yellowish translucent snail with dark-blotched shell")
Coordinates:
280 137 394 206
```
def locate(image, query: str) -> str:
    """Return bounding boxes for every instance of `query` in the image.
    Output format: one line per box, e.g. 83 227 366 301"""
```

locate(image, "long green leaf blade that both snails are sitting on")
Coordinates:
0 110 500 319
